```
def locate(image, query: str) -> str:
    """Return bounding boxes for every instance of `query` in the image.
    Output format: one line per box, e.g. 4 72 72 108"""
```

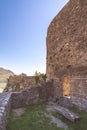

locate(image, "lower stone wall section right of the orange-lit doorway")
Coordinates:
70 76 87 110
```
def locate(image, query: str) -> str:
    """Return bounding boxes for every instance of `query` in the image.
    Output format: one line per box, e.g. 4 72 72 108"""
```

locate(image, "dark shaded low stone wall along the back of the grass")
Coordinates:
11 81 53 108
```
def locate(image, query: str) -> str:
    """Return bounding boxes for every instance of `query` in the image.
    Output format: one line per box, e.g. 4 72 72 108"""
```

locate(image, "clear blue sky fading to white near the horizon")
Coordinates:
0 0 68 75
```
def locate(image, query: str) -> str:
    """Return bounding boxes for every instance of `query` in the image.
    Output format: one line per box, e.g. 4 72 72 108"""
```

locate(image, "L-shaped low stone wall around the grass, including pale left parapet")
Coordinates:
0 81 53 130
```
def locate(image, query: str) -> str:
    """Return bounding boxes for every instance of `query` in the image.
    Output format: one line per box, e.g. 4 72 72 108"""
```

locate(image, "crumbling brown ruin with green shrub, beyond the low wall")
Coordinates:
4 73 45 92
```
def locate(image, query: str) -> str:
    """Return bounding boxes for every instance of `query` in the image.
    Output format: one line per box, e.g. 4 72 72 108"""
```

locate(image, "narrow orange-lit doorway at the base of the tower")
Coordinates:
63 76 70 97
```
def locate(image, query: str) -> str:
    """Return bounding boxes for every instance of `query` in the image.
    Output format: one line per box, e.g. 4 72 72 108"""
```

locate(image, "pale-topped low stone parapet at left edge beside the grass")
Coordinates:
0 93 11 130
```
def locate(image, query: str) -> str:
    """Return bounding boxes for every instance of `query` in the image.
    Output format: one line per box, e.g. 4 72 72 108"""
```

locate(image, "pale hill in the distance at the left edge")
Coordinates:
0 67 14 92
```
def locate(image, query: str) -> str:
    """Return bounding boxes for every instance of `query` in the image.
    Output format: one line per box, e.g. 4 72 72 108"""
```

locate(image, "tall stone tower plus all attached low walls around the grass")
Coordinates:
0 0 87 130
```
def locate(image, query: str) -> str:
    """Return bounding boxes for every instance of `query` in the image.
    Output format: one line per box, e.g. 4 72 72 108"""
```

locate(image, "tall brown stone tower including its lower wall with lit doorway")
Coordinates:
46 0 87 107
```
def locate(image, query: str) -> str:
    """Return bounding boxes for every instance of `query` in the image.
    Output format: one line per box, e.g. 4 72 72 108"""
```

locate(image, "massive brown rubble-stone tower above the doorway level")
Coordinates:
46 0 87 79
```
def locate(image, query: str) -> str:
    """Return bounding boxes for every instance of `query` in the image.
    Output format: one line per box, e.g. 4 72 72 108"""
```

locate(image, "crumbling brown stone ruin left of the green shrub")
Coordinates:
4 74 36 91
